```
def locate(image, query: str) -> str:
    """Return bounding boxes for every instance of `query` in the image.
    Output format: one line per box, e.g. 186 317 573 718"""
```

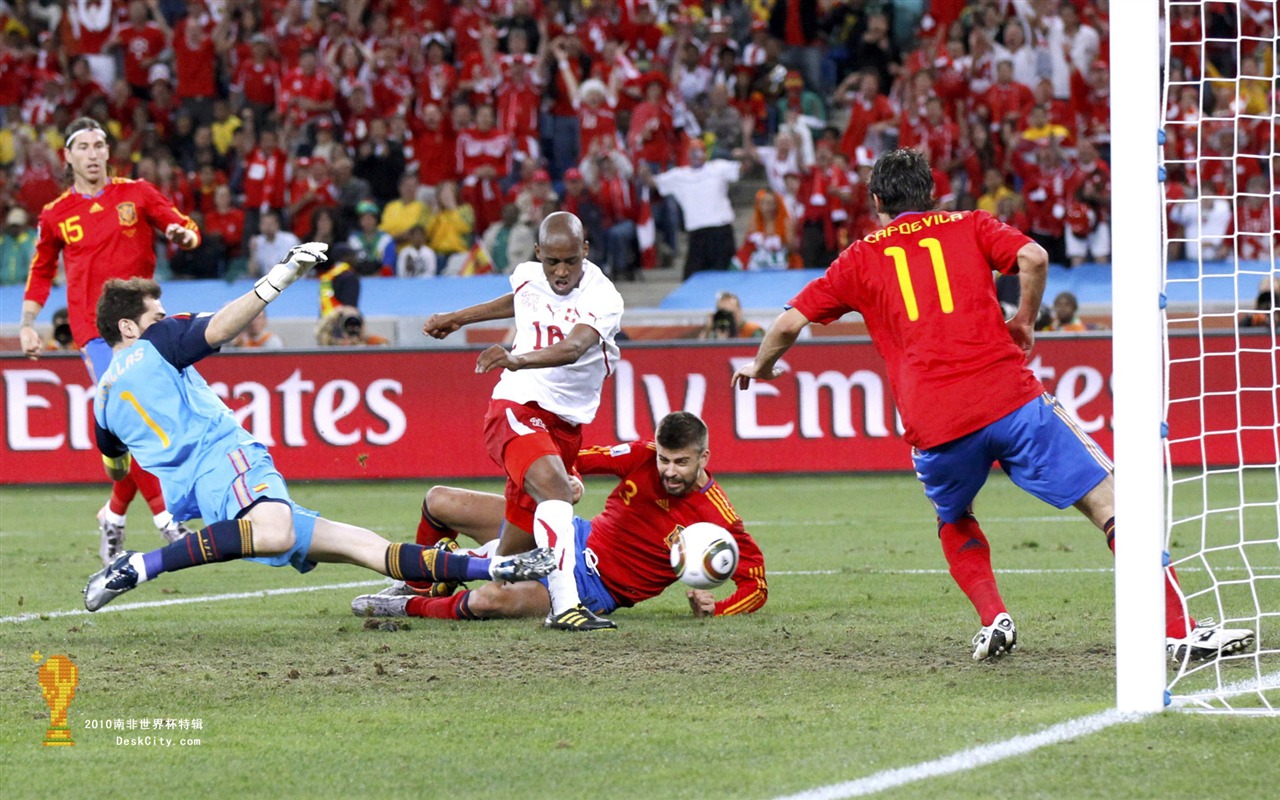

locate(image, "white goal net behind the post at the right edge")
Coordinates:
1162 0 1280 714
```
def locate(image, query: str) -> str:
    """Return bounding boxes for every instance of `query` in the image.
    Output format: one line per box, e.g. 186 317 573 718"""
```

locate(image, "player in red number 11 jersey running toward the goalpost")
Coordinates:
733 150 1253 660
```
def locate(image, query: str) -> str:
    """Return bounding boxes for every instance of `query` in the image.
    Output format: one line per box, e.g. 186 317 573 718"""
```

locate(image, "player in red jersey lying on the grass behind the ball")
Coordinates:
351 411 768 620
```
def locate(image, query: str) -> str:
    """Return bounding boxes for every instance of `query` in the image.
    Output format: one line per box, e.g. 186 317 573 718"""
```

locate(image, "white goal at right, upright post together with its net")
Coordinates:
1111 0 1280 714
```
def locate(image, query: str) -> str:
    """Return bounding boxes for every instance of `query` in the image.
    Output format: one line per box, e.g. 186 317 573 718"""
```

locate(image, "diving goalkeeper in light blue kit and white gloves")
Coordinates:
84 242 554 611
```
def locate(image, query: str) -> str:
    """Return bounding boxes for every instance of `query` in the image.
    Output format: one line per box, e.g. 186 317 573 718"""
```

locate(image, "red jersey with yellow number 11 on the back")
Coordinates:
793 211 1044 450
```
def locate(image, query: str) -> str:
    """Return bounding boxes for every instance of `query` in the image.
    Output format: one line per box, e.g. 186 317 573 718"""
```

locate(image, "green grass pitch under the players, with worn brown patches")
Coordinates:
0 465 1280 800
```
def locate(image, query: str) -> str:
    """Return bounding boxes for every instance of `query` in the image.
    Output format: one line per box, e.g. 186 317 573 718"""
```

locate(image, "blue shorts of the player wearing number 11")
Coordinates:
911 393 1114 522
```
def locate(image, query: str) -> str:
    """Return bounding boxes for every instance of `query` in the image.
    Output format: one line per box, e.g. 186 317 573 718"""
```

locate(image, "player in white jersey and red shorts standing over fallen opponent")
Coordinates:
422 211 622 631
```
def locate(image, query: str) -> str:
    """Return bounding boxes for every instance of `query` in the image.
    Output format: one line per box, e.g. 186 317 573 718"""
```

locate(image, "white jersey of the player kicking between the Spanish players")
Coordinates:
493 261 622 425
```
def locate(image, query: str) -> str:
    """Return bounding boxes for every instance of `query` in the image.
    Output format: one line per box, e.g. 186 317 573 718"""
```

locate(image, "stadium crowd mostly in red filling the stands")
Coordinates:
0 0 1277 291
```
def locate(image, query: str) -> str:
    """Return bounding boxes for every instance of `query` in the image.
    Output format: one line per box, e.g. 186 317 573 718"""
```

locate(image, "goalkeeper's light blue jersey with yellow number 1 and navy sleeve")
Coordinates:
93 314 256 520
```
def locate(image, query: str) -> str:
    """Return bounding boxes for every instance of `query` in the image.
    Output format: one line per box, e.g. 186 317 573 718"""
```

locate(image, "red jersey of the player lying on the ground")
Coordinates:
575 442 769 616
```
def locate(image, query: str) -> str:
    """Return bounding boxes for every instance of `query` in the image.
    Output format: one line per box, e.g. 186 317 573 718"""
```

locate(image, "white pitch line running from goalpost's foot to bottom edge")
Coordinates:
762 709 1147 800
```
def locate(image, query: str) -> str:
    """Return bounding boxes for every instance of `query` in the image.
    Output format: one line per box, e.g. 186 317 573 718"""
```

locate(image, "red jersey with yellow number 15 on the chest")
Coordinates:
22 178 200 347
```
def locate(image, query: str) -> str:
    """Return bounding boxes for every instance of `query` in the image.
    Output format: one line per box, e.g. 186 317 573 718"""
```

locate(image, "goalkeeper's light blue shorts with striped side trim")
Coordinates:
196 442 319 572
